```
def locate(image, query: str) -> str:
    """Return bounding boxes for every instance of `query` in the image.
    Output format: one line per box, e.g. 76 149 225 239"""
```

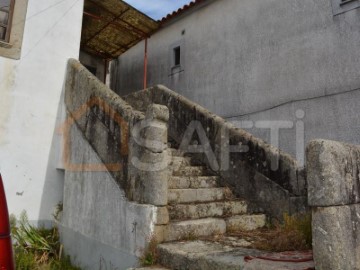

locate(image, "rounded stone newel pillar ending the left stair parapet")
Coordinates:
129 104 170 206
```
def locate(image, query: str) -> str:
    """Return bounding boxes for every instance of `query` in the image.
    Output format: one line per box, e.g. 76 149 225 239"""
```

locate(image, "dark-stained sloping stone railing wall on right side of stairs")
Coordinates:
124 85 306 219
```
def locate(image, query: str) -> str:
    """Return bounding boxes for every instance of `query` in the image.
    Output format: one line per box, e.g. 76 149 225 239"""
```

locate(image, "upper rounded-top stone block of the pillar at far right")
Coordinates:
306 140 360 206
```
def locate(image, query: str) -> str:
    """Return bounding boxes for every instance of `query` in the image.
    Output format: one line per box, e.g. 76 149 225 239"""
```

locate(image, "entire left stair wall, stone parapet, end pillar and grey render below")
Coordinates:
61 60 169 269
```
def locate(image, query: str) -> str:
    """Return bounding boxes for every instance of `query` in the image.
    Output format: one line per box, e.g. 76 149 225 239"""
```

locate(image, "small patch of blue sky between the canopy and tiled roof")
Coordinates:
124 0 191 20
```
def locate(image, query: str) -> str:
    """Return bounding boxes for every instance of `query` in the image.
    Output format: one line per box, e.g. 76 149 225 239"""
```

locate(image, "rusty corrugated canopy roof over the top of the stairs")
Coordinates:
81 0 159 59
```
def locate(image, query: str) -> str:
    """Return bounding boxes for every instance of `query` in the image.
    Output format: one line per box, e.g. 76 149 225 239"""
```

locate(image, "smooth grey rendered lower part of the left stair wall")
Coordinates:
60 125 159 270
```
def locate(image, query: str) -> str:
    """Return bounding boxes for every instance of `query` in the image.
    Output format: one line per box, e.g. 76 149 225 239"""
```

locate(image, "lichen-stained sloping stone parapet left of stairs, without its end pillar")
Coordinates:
65 60 144 196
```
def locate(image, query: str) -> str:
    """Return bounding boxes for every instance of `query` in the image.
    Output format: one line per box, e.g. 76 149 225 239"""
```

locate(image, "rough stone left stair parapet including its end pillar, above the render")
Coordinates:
65 60 169 206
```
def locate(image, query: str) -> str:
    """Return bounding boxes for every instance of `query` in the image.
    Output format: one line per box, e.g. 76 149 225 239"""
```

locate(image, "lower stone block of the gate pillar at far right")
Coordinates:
312 204 360 270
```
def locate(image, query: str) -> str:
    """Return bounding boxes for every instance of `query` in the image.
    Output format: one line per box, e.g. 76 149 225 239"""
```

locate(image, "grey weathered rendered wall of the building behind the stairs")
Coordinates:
113 0 360 159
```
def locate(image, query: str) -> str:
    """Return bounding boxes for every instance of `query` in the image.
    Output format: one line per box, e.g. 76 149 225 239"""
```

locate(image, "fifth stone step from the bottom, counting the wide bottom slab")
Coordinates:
169 176 219 189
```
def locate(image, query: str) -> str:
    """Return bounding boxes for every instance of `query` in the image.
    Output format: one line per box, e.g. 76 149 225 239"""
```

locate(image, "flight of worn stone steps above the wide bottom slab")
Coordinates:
165 148 266 241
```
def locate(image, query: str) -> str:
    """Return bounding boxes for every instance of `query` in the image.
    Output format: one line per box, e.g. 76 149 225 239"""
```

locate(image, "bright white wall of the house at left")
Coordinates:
0 0 83 224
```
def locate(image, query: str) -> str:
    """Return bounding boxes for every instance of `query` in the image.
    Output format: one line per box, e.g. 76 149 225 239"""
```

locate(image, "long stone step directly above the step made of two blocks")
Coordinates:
168 201 247 220
